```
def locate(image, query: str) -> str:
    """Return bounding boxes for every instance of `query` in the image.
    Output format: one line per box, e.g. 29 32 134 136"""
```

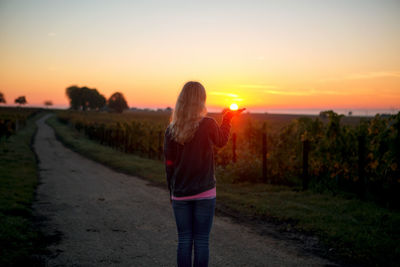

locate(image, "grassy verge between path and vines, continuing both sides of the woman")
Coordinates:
48 117 400 266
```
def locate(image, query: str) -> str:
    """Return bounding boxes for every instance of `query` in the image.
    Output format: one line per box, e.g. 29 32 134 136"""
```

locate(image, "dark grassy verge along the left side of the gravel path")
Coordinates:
0 112 41 266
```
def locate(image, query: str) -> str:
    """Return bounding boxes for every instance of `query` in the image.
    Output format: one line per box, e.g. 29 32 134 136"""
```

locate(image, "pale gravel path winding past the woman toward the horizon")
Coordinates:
34 117 334 266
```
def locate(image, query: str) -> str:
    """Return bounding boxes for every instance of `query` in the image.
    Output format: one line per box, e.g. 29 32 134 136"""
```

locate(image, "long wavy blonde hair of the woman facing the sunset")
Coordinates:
169 81 207 144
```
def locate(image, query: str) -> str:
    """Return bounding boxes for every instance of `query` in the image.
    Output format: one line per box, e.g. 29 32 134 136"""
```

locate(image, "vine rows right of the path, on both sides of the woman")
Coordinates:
58 111 400 207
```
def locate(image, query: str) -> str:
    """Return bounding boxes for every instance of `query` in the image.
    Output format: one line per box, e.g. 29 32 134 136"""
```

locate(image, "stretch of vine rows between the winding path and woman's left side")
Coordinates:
58 111 169 160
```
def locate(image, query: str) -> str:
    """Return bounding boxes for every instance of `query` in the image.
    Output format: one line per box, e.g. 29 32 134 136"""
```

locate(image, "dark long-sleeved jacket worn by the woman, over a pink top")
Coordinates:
164 117 231 197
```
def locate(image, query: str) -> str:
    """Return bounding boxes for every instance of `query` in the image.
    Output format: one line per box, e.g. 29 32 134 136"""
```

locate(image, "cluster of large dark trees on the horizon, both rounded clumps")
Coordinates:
66 85 128 113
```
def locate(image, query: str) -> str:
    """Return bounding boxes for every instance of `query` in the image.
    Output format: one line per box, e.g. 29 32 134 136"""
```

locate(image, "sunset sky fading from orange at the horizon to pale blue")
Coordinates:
0 0 400 113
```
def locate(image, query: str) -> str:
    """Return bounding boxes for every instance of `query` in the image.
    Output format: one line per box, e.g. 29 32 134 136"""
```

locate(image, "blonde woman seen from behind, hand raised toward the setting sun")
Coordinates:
164 82 244 267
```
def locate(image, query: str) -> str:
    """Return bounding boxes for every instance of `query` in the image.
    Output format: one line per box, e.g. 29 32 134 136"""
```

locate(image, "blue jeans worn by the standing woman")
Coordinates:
172 198 215 267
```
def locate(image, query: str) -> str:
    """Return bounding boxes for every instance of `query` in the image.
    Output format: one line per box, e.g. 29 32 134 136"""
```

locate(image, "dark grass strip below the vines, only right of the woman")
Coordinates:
218 183 400 266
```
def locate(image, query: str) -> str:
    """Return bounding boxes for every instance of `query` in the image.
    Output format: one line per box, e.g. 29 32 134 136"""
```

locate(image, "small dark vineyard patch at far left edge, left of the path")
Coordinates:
0 107 39 142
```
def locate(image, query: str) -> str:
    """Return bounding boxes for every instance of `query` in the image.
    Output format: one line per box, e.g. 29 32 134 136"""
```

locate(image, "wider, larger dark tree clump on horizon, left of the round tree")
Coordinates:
66 85 106 110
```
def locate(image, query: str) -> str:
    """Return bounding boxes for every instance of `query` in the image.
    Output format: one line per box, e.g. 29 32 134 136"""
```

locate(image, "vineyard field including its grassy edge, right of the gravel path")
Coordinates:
49 112 400 265
